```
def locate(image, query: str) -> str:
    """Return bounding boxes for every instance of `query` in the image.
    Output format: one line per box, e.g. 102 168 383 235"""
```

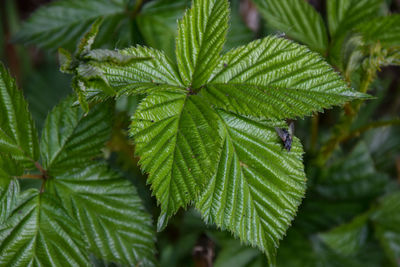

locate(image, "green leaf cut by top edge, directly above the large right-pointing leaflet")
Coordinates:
254 0 328 54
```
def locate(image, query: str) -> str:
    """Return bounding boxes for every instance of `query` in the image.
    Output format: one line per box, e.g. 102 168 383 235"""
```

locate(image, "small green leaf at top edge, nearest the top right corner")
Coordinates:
327 0 382 37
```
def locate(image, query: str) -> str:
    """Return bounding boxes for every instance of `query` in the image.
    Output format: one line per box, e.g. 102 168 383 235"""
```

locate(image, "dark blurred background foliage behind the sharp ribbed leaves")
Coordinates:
0 0 400 267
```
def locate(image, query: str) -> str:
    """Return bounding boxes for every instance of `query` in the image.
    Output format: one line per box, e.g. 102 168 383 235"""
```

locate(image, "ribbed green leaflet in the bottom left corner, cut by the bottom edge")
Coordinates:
0 189 89 267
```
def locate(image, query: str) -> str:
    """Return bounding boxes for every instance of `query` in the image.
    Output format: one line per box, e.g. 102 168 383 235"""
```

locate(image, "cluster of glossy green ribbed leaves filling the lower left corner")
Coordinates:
0 65 155 266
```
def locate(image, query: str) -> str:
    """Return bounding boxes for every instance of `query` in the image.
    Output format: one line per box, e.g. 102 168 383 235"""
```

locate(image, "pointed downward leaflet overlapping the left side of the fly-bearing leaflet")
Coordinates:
130 92 220 230
